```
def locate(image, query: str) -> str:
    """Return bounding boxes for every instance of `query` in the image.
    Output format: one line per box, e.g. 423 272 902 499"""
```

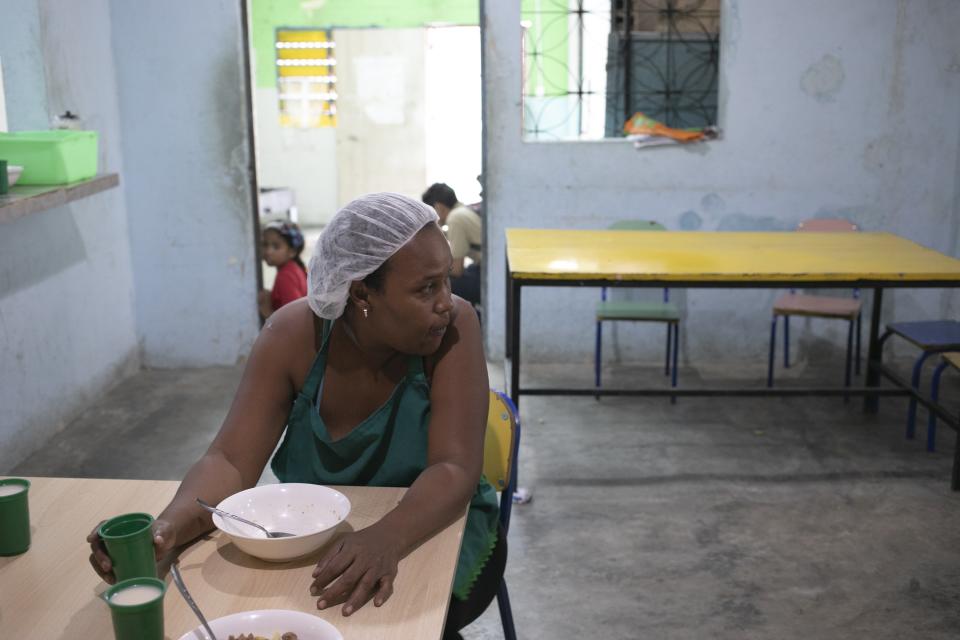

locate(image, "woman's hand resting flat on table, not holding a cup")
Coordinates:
310 525 401 616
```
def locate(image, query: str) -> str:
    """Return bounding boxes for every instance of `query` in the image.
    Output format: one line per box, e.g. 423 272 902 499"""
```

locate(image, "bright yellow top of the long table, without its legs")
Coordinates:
507 229 960 284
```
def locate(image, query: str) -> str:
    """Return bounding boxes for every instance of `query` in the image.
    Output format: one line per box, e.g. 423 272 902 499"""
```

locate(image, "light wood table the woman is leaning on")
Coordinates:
0 478 465 640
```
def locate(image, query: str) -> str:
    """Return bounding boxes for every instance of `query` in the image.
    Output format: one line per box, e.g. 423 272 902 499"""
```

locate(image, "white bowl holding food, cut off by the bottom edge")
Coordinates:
180 609 343 640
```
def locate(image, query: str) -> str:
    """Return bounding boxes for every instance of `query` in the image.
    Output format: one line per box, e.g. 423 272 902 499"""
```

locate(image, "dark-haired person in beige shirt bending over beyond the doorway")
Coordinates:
421 182 483 305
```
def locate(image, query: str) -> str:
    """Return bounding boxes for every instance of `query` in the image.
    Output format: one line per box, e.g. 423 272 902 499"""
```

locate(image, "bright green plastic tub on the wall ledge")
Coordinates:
0 129 98 185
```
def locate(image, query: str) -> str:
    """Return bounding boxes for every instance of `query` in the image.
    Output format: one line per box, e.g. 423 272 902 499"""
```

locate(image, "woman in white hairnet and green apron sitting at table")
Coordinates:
88 193 506 638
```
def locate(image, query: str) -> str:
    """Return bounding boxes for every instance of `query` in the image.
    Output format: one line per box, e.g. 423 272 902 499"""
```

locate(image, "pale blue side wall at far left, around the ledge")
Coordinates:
0 0 139 473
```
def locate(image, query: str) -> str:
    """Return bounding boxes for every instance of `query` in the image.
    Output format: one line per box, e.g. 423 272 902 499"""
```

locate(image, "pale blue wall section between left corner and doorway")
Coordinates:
110 0 258 367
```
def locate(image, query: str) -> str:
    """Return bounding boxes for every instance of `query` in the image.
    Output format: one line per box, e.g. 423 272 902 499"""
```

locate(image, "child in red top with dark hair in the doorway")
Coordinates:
257 221 307 318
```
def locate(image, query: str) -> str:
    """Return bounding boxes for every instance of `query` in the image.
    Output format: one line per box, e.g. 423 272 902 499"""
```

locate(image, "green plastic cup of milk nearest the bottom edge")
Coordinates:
100 578 167 640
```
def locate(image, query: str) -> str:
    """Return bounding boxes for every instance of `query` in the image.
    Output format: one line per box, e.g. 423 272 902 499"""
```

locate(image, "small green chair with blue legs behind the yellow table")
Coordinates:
593 220 680 404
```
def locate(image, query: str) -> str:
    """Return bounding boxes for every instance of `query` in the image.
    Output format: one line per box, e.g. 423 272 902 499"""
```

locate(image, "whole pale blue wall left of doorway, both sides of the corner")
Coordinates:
0 0 258 473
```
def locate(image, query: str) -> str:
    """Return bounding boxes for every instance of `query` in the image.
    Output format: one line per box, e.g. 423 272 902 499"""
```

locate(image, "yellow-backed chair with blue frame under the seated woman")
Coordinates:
483 389 520 640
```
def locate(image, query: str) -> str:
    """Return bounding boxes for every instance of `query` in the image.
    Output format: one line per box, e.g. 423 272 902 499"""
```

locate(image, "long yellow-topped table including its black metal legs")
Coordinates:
506 229 960 484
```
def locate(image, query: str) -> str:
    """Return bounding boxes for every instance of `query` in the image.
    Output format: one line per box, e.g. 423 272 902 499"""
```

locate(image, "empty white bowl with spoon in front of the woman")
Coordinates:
213 483 350 562
